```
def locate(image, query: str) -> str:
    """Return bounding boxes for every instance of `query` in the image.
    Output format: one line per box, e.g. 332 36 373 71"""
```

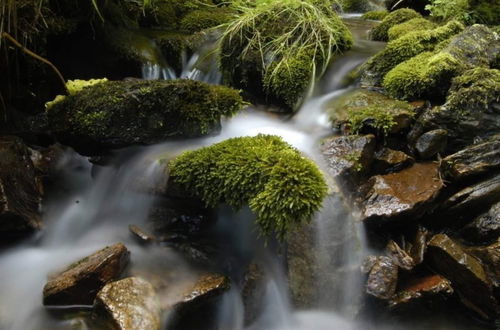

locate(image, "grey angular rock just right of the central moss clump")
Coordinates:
321 134 376 189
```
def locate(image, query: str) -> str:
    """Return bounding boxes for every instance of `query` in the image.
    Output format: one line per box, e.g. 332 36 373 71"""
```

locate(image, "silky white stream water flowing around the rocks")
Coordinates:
0 18 488 330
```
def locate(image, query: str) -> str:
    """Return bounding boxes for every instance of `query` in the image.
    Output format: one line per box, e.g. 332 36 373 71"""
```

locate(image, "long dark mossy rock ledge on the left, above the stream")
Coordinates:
47 80 244 155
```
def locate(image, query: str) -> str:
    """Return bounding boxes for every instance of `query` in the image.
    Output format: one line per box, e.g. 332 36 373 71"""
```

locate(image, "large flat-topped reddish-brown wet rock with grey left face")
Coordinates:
360 163 443 222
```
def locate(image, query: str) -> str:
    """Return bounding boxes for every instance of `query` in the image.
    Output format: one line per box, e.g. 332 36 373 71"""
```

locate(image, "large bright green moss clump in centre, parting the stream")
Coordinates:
170 135 327 239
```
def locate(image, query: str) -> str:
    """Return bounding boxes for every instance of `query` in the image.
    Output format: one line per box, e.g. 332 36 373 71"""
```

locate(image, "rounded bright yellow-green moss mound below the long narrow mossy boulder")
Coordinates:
383 52 462 100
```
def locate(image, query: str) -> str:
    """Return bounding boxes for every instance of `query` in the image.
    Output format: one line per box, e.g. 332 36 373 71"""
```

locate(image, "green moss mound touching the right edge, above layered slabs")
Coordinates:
446 68 500 113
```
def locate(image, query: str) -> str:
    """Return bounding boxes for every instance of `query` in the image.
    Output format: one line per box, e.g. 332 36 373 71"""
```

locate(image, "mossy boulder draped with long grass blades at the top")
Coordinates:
220 0 352 111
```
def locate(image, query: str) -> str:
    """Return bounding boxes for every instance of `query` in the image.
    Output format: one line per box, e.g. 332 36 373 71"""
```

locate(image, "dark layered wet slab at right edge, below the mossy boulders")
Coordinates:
441 135 500 181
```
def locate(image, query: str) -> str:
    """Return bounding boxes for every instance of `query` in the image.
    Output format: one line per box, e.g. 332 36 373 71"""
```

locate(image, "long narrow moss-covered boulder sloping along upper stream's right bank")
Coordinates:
362 21 464 86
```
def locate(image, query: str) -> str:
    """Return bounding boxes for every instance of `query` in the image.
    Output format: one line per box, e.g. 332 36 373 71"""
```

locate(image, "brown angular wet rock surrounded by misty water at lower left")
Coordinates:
43 243 130 305
